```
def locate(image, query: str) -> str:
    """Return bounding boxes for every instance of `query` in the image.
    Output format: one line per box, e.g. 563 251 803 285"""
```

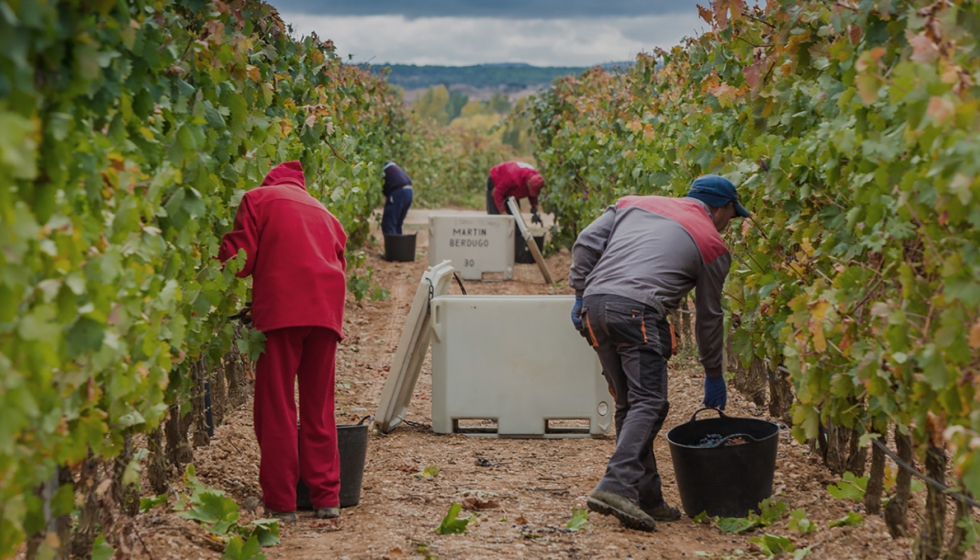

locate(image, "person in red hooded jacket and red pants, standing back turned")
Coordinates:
218 161 347 521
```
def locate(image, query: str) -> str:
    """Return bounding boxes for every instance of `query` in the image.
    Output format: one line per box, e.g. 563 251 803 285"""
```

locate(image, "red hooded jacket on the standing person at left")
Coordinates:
218 161 347 337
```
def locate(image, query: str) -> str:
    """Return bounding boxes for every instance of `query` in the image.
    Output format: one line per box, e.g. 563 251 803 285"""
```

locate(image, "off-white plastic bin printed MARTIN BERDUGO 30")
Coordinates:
429 216 514 280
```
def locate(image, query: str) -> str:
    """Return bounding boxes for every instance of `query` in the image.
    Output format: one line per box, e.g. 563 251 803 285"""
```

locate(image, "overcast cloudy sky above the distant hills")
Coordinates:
271 0 710 66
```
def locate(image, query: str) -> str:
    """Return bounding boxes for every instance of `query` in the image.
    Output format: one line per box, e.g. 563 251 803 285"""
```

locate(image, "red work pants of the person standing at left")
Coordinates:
254 327 340 511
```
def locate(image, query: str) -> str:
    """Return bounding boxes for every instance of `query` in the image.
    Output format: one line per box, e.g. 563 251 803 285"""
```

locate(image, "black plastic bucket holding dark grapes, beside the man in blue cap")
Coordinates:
667 408 779 517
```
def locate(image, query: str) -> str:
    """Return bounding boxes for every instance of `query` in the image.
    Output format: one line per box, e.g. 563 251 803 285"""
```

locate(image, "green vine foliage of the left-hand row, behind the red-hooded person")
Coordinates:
0 0 407 557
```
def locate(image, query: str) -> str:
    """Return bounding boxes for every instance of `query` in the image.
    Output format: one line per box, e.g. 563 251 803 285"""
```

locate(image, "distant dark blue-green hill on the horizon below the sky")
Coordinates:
364 63 632 90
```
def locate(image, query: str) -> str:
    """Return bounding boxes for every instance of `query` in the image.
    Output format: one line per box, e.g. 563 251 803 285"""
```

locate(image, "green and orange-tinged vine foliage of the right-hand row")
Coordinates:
531 0 980 504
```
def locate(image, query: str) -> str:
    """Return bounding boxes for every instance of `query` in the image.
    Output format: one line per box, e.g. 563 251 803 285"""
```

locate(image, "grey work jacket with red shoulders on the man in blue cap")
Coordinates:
568 196 732 376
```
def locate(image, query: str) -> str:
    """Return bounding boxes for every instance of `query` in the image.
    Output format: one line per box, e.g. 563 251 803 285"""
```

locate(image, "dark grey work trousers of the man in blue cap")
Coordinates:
583 295 671 510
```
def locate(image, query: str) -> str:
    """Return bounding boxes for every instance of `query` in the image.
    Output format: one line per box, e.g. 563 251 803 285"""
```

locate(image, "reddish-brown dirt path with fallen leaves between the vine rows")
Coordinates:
144 214 914 559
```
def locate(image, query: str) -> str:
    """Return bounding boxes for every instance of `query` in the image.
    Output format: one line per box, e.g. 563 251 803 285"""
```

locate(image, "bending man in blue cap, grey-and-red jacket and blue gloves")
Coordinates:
568 175 749 531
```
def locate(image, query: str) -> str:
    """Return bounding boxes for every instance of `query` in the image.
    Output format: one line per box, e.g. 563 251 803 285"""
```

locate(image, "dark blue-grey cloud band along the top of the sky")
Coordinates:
271 0 710 19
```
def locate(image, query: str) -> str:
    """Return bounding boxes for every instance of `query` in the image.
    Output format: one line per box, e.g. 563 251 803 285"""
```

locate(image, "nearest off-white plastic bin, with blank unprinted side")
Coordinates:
430 295 614 438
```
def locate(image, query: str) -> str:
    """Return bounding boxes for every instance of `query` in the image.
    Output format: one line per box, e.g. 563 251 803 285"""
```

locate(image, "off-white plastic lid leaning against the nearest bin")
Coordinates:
374 261 454 434
